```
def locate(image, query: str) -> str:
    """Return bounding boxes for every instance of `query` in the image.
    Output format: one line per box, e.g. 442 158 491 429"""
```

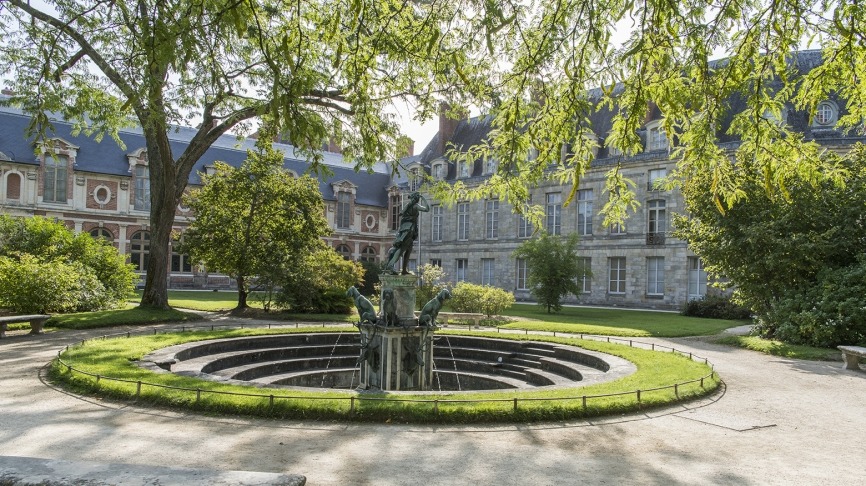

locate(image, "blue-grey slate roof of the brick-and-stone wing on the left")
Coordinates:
0 103 391 207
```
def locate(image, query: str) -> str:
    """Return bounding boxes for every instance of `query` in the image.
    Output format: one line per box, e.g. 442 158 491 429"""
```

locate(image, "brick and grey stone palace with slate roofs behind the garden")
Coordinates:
0 51 866 309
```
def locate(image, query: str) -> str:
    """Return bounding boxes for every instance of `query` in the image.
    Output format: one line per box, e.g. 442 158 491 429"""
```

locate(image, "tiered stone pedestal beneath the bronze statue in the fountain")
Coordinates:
358 275 437 391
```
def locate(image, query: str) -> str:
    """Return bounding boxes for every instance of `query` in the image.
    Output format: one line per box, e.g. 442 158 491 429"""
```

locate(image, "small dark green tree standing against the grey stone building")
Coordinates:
512 233 584 313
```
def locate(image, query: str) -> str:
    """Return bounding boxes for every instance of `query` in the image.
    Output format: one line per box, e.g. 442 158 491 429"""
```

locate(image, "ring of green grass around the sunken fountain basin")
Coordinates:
49 327 721 423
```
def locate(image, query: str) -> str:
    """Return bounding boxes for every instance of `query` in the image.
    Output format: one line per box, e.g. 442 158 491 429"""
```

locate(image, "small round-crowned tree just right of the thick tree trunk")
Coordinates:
179 138 330 310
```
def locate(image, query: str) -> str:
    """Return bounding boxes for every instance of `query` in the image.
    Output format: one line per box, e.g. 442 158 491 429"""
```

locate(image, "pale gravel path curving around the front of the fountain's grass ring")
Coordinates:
0 318 866 486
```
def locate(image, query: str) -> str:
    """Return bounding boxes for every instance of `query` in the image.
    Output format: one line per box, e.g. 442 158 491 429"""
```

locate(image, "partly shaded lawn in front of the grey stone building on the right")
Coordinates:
500 304 747 337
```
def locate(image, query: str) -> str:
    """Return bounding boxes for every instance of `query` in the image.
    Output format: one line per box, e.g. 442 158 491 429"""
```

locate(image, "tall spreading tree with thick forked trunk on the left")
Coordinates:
0 0 484 307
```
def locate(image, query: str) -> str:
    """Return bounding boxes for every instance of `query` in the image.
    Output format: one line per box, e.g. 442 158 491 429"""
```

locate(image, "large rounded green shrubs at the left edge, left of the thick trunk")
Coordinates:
0 215 138 312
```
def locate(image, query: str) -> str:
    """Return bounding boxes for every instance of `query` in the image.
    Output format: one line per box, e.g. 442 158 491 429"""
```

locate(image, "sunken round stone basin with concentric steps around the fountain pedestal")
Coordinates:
139 332 636 392
